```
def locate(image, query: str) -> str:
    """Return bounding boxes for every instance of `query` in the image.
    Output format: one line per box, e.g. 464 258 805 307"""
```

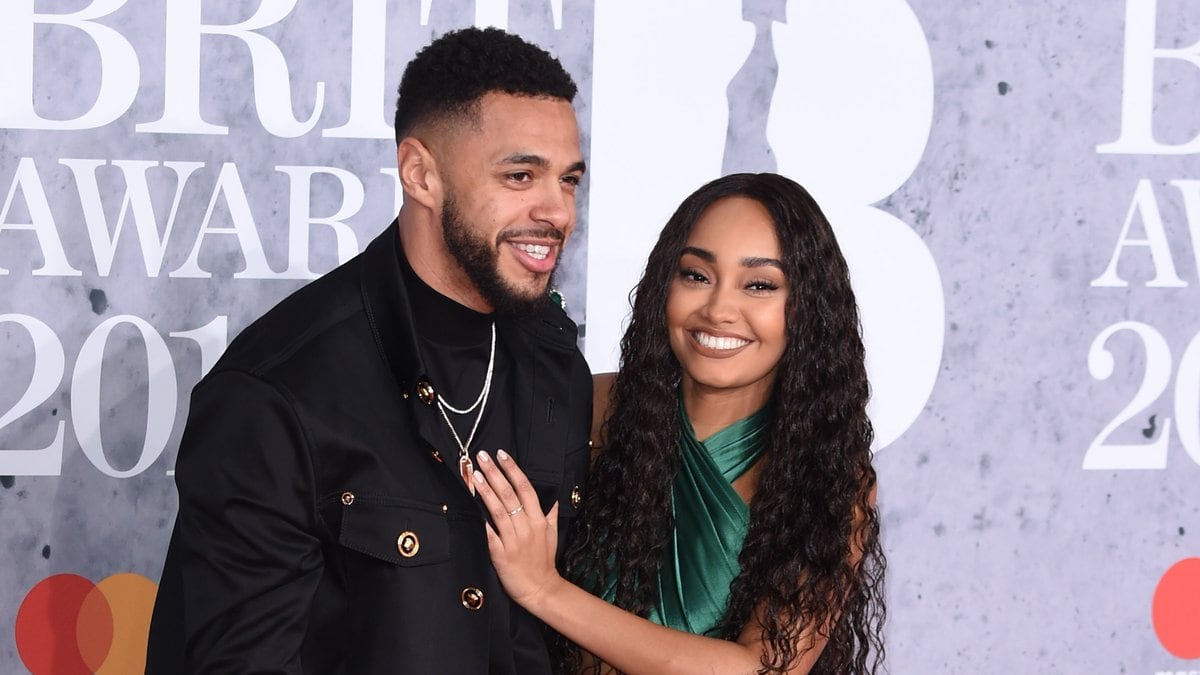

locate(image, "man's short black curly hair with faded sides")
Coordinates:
395 28 578 144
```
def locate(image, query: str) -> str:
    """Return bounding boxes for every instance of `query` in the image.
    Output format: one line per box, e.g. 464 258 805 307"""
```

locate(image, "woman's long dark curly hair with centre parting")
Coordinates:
560 173 886 674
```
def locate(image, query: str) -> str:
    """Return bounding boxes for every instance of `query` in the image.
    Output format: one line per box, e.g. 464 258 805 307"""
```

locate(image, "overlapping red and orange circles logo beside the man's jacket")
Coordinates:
16 574 158 675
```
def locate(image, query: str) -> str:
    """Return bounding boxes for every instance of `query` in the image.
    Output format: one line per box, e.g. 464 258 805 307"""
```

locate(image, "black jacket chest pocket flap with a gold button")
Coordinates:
338 500 450 567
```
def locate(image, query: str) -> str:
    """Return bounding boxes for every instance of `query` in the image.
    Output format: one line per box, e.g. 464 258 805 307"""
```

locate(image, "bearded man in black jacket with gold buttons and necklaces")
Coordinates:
148 29 592 675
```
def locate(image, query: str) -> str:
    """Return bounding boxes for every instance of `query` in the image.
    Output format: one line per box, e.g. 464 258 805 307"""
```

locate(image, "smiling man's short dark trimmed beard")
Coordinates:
442 198 563 317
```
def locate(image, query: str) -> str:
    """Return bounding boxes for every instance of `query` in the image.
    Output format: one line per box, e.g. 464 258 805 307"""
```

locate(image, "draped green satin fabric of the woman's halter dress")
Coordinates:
649 401 769 635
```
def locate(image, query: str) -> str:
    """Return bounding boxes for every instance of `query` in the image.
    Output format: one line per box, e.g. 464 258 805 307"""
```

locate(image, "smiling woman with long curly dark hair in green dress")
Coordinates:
474 174 884 674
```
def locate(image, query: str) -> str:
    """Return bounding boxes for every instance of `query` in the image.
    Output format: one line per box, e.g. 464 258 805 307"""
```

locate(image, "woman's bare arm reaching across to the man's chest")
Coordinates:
474 452 828 675
